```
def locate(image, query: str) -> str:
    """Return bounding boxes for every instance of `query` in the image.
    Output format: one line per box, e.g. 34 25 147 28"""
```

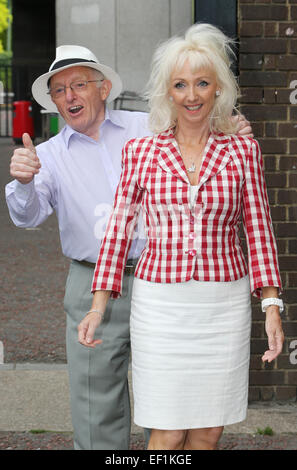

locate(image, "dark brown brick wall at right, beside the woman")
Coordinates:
238 0 297 401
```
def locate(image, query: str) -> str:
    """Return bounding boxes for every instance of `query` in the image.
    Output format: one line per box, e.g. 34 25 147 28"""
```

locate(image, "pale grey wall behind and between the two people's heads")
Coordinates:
56 0 192 103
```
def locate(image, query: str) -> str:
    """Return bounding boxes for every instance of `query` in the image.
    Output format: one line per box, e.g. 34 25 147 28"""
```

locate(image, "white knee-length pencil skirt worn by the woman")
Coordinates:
131 276 251 430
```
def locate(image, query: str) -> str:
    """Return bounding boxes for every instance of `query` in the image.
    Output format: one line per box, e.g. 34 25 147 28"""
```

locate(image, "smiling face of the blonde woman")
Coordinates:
169 61 218 126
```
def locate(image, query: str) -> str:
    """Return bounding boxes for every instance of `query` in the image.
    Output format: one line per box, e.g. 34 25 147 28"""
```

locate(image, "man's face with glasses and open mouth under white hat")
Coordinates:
50 67 111 140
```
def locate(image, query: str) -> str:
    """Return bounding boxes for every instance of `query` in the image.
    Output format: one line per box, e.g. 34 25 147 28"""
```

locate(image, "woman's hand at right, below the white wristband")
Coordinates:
262 305 285 362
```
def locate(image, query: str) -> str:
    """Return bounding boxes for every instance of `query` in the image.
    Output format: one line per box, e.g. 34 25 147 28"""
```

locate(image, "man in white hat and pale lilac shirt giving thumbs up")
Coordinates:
6 46 251 450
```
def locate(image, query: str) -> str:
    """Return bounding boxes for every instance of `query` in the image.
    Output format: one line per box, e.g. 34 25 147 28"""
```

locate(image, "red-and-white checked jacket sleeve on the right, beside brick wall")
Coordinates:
242 141 281 297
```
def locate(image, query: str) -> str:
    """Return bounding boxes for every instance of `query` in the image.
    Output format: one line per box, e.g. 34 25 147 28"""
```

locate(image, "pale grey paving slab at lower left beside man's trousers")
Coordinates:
0 368 72 431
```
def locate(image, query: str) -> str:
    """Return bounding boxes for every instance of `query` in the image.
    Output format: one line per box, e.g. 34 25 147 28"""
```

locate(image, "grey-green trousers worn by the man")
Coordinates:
64 261 133 450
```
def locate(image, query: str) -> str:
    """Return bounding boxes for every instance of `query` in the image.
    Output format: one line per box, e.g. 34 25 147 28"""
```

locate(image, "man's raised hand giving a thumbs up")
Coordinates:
10 134 41 184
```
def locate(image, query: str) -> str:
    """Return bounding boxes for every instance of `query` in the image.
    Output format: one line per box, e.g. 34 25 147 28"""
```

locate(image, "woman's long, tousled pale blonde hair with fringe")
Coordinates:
145 23 239 134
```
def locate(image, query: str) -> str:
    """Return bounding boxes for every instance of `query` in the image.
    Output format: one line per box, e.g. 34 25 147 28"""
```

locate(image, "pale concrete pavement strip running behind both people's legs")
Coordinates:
0 363 297 438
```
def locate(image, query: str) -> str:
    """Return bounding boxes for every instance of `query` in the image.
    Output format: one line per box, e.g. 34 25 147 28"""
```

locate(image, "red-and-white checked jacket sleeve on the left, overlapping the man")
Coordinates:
92 141 143 298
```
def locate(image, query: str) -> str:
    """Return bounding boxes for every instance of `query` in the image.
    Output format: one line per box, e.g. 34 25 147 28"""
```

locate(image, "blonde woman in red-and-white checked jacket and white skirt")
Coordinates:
79 24 283 449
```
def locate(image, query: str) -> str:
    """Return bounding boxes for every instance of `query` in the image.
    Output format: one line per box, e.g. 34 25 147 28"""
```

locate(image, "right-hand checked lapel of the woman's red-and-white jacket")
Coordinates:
198 135 232 187
